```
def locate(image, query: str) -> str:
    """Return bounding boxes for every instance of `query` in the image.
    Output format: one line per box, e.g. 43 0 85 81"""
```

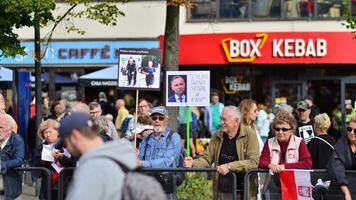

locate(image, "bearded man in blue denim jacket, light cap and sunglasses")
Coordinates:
137 106 181 199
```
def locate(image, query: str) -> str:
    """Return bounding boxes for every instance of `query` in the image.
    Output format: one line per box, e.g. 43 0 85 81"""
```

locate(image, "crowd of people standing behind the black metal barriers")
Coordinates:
0 92 356 199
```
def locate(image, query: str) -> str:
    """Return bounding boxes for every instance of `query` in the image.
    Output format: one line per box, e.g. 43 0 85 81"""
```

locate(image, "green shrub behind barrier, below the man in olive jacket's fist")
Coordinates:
177 172 213 200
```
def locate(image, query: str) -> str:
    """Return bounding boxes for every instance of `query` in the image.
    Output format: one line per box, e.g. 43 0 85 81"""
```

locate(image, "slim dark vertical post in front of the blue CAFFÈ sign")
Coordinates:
34 10 42 143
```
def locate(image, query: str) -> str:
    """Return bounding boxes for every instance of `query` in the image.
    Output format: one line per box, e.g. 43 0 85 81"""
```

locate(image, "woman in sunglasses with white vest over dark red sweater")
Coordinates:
258 111 312 173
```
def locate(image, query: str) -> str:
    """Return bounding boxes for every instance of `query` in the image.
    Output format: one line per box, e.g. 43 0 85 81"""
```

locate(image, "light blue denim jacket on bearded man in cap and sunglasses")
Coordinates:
138 128 181 168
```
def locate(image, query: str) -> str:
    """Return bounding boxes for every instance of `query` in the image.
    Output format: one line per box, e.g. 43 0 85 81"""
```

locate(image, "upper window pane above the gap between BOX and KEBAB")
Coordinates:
252 0 281 18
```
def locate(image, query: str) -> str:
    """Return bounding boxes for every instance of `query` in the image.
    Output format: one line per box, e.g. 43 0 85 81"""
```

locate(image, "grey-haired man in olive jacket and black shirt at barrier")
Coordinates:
184 106 260 199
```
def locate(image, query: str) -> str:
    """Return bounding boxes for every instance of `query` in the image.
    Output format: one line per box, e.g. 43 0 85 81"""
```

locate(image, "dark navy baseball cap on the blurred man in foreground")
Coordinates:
55 112 93 148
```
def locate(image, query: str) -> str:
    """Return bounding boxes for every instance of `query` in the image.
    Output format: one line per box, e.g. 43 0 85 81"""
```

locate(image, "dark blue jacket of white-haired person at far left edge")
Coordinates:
0 134 25 199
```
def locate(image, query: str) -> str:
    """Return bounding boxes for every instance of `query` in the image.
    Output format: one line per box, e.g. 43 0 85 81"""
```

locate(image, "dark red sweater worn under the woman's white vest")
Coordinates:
258 140 312 169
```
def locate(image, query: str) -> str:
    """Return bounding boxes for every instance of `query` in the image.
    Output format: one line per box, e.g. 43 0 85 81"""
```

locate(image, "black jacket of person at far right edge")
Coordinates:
328 135 356 187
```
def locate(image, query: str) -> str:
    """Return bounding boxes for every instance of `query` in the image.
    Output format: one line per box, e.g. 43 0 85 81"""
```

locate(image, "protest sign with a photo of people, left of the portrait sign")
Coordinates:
118 48 161 90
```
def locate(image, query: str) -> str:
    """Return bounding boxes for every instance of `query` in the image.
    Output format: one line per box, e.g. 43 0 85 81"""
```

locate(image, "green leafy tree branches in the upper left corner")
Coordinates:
0 0 128 57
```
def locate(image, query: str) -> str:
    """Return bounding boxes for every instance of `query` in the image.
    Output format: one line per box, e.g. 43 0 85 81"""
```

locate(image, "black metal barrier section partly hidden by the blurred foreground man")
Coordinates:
58 168 237 200
